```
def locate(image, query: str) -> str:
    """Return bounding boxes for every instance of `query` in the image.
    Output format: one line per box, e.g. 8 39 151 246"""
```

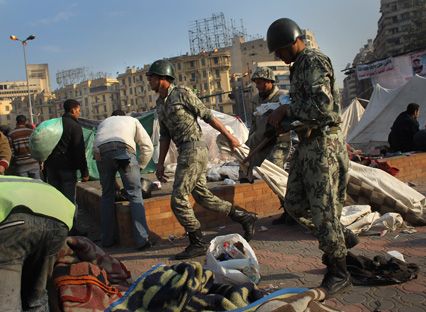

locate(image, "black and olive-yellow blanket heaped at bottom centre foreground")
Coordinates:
107 262 265 312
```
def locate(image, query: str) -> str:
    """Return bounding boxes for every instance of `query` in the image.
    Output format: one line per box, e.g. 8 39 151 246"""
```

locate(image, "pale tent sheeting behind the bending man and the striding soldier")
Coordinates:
79 110 248 179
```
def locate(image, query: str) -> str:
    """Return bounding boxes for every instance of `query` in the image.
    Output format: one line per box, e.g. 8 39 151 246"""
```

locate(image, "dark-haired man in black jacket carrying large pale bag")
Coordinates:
45 99 89 234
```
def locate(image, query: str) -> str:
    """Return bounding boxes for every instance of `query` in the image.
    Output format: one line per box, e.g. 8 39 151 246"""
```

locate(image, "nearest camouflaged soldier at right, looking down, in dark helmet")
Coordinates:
267 18 351 294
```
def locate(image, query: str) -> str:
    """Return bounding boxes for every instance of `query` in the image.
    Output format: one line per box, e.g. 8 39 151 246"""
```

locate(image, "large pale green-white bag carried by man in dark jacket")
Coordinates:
30 117 64 161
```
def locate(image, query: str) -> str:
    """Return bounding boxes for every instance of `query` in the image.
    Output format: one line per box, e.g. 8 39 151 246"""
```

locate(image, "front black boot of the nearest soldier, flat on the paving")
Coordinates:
320 257 352 295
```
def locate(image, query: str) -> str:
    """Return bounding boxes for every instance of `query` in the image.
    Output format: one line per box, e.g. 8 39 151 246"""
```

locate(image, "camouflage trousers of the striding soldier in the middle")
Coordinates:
171 147 232 232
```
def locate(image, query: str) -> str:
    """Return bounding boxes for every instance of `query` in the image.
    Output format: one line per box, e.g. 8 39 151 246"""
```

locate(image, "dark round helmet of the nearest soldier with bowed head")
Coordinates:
266 18 303 53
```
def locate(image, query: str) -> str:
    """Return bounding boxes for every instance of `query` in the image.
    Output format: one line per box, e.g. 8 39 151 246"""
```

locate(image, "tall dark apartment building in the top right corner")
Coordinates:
374 0 426 59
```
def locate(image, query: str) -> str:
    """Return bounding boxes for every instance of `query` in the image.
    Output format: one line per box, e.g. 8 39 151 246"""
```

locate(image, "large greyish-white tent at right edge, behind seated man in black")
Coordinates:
347 75 426 152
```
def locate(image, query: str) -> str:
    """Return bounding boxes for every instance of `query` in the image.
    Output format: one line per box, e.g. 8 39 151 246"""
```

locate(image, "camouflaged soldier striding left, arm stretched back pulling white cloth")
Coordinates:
146 60 257 259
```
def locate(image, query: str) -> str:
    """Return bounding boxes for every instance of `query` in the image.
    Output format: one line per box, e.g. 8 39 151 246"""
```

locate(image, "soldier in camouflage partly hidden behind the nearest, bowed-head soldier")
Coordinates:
240 67 294 224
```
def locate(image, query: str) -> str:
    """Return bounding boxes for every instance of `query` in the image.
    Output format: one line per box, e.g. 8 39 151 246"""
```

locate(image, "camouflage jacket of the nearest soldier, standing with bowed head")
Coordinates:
289 48 341 126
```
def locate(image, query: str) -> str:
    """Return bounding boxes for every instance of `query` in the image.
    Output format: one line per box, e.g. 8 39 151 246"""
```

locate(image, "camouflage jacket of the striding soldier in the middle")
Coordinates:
157 85 213 147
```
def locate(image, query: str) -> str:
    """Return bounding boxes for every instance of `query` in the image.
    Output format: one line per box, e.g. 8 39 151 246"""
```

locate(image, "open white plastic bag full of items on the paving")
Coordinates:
205 234 260 285
